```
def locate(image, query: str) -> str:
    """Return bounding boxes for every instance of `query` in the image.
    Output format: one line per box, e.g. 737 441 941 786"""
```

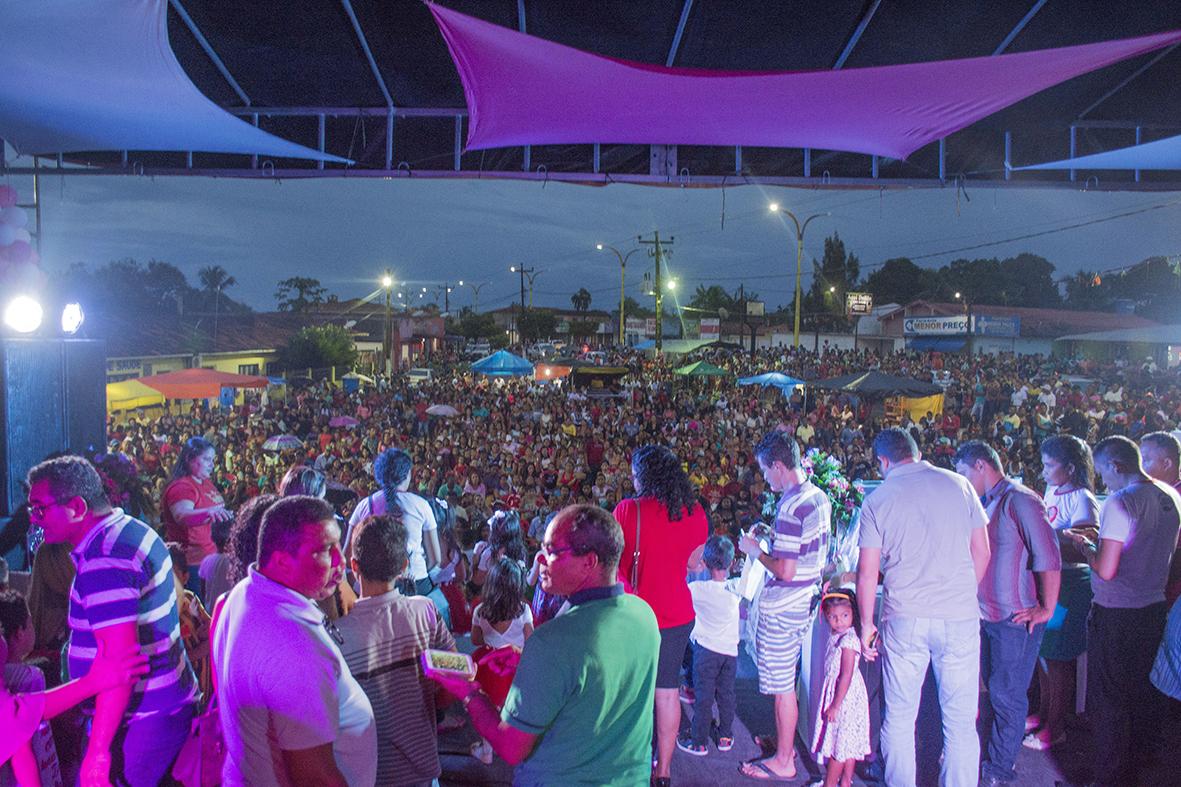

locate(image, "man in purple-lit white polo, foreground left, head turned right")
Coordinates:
213 495 377 787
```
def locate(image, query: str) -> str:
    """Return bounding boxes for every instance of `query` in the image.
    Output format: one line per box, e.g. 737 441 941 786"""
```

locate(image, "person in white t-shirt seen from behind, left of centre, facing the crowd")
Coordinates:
345 448 441 596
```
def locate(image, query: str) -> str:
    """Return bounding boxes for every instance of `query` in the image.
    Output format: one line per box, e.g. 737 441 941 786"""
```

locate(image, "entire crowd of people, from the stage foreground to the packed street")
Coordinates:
0 349 1181 785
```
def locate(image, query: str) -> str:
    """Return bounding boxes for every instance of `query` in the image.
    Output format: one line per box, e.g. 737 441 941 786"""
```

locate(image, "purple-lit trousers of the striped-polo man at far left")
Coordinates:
79 703 196 787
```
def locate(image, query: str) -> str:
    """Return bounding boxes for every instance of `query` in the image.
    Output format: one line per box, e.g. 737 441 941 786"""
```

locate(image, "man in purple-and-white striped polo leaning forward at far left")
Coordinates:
28 456 198 787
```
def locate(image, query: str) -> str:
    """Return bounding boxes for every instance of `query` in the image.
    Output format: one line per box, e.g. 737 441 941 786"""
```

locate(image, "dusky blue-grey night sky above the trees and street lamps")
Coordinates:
7 159 1181 311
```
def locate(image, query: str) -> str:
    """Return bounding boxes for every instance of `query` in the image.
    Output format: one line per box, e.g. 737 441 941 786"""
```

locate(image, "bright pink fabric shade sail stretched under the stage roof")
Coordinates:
430 4 1181 158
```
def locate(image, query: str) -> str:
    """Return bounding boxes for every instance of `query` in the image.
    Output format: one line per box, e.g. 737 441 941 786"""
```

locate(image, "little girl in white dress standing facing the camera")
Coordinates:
813 590 869 787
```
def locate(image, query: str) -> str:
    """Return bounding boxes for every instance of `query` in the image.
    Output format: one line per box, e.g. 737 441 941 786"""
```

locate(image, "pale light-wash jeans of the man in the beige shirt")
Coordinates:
879 617 980 787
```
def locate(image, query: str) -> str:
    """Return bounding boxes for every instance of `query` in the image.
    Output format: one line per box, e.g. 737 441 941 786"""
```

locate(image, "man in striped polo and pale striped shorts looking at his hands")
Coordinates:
738 431 833 779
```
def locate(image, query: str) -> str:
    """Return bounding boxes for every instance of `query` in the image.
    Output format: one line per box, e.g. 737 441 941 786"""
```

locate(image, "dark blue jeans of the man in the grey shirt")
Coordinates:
980 620 1045 781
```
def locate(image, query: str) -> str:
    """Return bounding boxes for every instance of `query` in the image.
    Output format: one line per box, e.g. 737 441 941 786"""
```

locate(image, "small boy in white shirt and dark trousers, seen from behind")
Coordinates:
677 535 738 756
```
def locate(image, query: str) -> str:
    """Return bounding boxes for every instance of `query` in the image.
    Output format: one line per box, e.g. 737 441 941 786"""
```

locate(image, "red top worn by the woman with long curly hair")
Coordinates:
614 497 710 629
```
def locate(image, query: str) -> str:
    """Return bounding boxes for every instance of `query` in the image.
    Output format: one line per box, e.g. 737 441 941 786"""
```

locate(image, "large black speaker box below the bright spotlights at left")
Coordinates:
0 338 106 516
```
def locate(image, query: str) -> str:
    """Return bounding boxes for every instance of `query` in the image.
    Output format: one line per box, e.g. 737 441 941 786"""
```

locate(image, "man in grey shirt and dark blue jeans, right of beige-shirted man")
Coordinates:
954 440 1062 787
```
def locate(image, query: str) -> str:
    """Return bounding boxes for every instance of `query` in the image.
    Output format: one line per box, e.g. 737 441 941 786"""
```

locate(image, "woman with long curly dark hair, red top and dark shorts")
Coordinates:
614 445 710 783
